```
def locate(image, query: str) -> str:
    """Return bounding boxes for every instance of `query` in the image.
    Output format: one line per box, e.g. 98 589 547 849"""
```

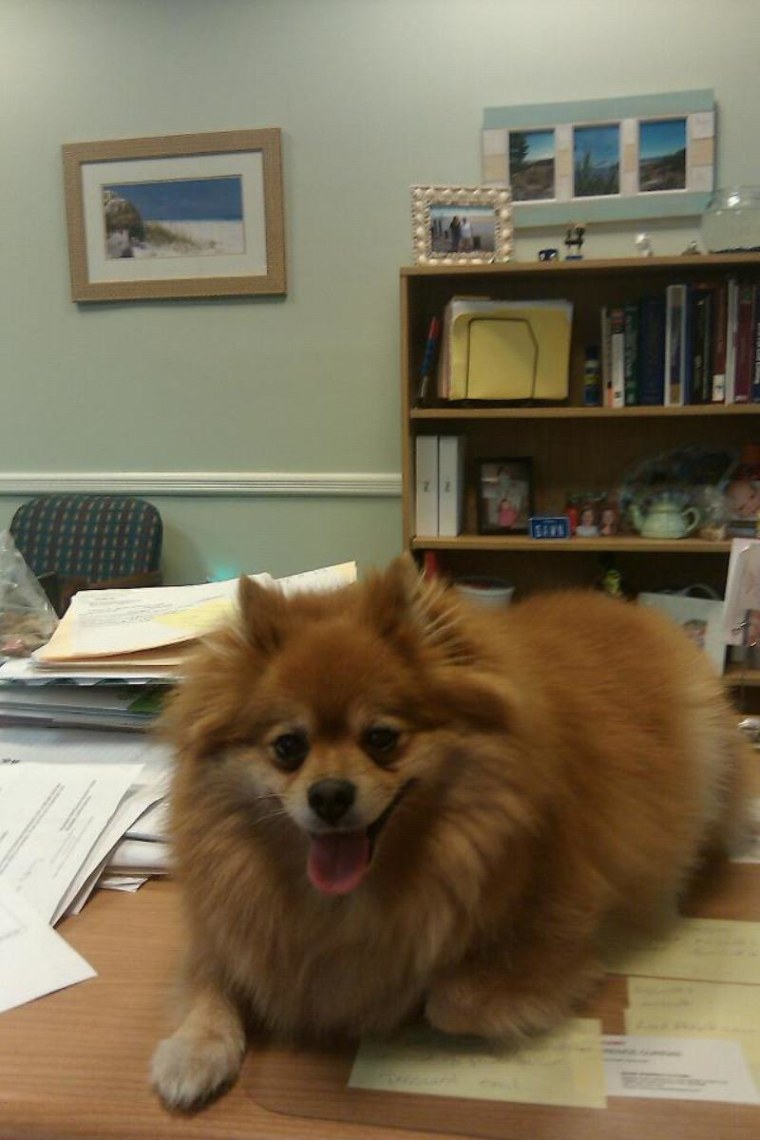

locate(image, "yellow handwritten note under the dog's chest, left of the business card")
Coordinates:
349 1018 606 1108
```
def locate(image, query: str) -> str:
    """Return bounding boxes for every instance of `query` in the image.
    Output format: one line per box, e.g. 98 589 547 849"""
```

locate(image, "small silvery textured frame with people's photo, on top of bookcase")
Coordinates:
411 186 513 264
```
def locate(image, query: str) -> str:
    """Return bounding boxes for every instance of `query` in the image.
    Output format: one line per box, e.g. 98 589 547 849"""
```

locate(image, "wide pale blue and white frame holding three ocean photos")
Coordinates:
481 89 716 226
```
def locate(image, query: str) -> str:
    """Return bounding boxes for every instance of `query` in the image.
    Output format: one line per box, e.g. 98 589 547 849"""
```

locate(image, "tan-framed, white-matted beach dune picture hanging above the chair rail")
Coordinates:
63 128 286 301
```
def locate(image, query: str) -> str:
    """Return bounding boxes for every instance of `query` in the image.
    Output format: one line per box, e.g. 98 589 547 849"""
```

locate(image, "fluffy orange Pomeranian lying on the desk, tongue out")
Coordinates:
152 557 753 1109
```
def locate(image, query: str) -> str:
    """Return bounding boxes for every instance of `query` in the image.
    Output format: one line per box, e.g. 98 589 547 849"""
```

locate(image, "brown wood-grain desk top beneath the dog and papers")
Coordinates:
0 865 760 1140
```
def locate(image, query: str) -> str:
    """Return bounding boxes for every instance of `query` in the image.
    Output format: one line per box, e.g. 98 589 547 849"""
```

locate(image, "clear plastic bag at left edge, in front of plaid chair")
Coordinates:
0 530 58 657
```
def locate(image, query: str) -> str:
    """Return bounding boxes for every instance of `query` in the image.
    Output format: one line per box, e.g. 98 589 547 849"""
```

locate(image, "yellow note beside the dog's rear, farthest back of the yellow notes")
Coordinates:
606 919 760 985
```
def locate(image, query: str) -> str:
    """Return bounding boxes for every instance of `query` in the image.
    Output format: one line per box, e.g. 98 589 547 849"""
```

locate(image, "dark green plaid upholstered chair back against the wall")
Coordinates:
10 495 163 616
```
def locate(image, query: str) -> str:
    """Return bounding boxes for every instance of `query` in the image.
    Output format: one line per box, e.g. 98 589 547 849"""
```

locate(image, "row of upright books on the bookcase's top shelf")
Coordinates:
602 278 760 407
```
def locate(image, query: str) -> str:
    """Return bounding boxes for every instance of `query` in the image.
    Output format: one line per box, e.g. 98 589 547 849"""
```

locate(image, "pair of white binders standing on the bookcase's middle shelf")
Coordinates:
415 435 465 537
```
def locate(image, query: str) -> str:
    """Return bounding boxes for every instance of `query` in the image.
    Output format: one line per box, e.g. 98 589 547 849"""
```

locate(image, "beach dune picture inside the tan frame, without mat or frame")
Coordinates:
103 176 245 260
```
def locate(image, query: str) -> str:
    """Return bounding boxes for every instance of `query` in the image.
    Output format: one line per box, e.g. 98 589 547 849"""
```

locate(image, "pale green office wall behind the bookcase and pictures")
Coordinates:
0 0 760 583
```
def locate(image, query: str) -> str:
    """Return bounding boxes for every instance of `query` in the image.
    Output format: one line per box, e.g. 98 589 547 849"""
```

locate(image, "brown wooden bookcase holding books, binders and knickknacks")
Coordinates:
401 254 760 611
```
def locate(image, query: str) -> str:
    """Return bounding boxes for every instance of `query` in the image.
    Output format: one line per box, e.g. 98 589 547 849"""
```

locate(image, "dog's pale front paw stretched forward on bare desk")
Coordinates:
150 1032 243 1112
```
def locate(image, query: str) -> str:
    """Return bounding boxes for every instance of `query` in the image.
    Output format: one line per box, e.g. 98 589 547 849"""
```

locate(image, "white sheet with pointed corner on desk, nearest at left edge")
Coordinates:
0 882 96 1012
